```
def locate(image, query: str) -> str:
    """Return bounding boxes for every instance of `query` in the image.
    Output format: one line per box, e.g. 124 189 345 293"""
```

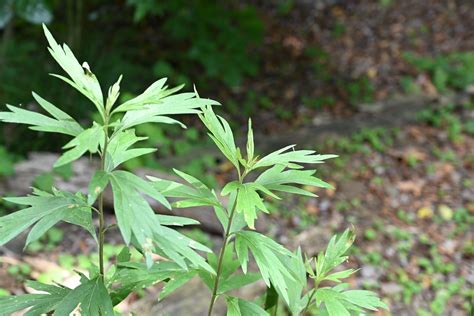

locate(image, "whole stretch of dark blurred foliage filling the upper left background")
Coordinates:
0 0 263 156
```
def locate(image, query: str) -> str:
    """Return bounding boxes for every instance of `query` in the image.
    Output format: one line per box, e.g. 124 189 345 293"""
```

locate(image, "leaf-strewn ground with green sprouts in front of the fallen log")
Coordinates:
277 106 474 315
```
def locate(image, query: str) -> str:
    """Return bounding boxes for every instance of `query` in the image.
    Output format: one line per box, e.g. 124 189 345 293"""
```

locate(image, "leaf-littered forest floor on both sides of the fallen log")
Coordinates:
0 0 474 316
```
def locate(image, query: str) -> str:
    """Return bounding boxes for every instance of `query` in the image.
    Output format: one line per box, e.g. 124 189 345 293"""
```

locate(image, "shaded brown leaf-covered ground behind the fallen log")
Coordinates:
229 0 474 133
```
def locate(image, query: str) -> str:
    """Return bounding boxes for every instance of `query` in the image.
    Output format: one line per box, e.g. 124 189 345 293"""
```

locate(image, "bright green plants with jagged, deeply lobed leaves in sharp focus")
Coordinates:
0 27 386 315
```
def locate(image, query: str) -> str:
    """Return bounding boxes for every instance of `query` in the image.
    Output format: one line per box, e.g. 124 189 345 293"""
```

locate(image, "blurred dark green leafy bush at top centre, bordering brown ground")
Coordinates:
128 0 263 86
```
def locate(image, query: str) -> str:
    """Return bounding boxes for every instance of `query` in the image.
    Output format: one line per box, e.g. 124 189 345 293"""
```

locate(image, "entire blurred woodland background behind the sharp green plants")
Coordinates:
0 0 474 315
